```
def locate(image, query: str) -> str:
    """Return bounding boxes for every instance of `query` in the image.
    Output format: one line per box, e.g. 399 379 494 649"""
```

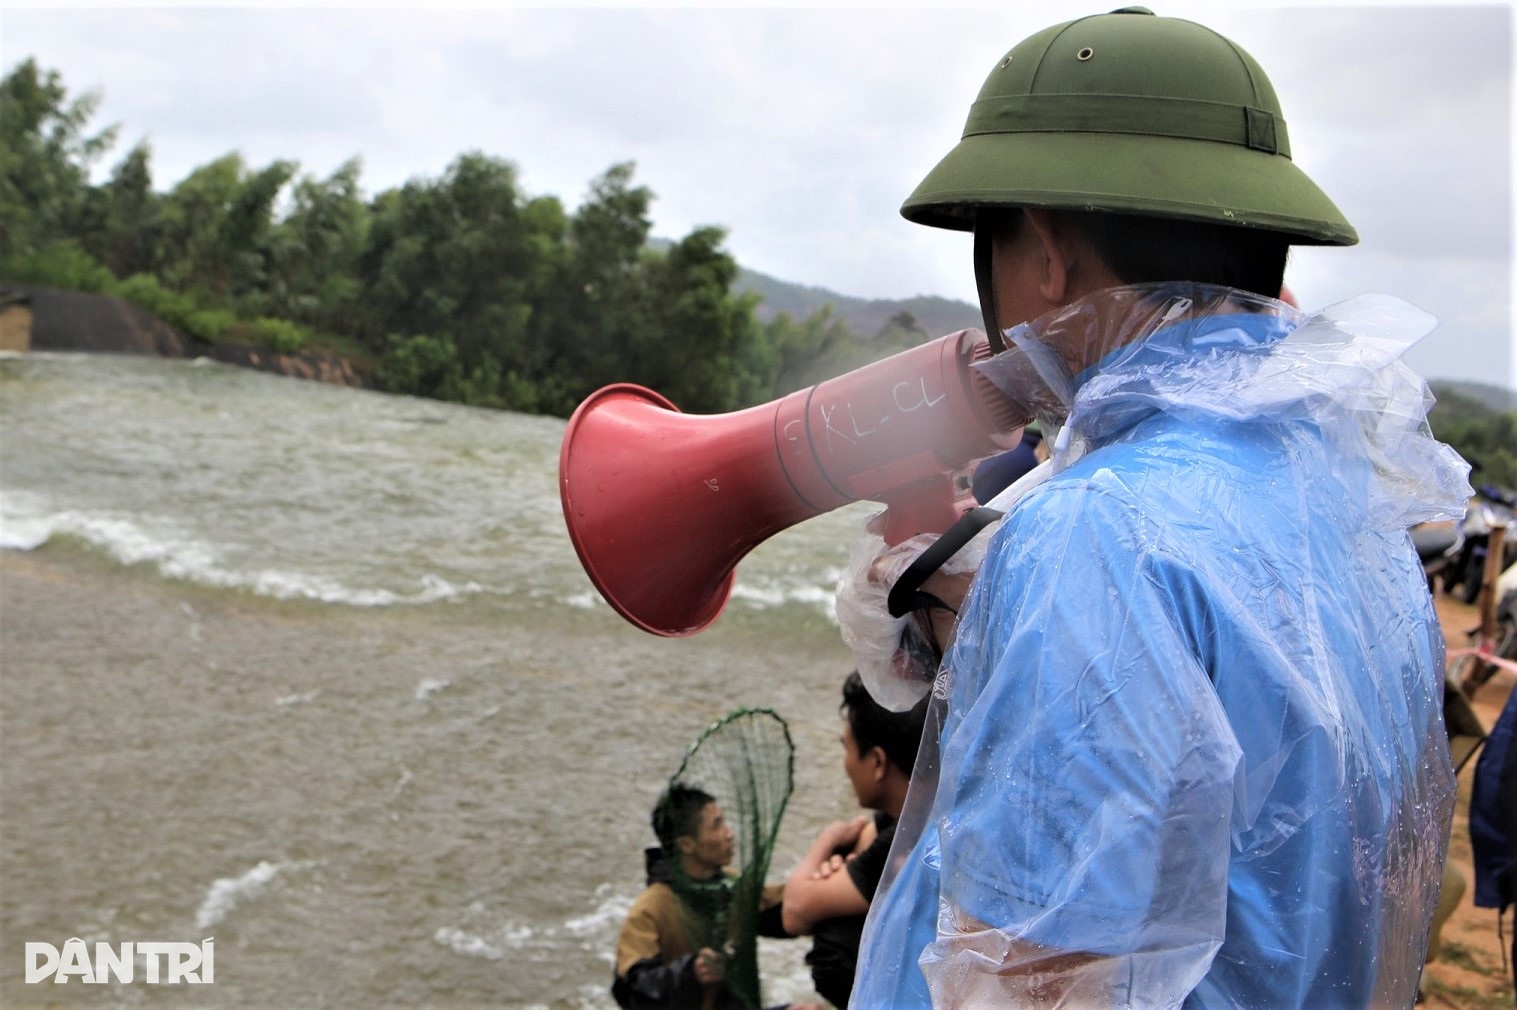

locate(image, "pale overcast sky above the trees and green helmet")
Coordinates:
0 0 1517 388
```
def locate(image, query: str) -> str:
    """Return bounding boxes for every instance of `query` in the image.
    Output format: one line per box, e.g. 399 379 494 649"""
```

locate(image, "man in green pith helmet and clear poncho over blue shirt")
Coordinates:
854 8 1468 1010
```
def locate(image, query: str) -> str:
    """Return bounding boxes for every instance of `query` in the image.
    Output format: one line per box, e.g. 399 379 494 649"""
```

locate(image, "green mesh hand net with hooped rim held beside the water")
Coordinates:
669 708 795 1010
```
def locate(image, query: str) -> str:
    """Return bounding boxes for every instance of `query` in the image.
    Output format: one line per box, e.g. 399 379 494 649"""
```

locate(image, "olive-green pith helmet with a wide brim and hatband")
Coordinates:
901 8 1359 246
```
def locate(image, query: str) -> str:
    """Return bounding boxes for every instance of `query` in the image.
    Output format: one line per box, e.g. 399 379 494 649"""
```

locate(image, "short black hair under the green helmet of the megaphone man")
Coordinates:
1069 212 1289 299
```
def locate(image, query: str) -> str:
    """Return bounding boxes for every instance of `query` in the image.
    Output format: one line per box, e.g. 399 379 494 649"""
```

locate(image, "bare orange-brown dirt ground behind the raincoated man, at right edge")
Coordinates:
1418 591 1517 1010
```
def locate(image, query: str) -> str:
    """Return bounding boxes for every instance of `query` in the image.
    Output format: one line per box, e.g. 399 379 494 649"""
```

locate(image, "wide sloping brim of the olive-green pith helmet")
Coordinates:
901 132 1359 246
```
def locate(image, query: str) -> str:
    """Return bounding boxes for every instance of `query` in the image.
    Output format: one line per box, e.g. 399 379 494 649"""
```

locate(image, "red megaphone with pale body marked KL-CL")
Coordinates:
558 329 1025 637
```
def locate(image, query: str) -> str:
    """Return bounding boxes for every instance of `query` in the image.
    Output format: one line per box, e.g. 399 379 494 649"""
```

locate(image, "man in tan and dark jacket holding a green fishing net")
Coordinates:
611 710 821 1010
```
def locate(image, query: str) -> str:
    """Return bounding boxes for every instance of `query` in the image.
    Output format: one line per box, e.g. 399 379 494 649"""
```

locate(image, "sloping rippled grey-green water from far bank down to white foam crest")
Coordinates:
0 355 878 620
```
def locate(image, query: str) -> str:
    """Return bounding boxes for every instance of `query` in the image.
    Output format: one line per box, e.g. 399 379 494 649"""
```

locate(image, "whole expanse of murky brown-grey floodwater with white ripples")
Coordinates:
0 355 874 1010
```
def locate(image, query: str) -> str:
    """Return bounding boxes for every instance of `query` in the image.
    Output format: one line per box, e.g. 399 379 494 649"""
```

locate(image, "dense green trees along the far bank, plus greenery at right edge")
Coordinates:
0 59 1517 488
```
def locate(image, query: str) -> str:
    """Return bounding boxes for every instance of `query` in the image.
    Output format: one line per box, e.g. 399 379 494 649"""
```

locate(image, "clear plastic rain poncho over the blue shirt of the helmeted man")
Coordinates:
854 285 1468 1010
